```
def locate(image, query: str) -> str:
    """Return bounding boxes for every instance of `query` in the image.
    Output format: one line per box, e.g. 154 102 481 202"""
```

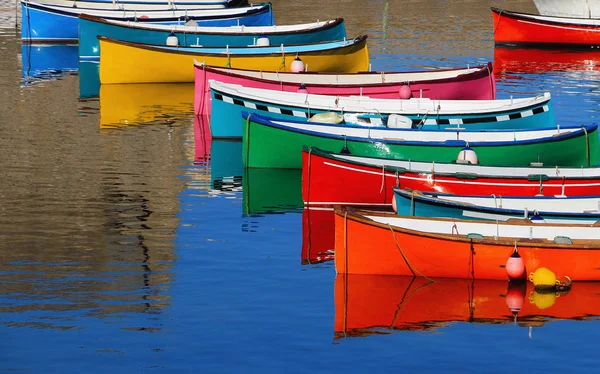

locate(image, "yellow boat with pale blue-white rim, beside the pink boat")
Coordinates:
98 35 369 84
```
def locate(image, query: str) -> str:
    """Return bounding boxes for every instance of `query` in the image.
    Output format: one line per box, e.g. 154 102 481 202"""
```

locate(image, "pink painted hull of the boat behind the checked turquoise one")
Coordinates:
194 63 496 115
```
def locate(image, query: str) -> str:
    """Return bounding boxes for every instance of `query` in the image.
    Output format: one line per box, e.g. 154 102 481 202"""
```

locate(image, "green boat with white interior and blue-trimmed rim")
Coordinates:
242 112 600 169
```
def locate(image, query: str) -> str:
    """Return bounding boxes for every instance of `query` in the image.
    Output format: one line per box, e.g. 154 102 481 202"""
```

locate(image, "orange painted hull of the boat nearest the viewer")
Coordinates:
335 210 600 281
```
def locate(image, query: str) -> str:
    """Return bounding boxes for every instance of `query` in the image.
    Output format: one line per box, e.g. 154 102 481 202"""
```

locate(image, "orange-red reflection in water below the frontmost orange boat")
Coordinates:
334 274 600 339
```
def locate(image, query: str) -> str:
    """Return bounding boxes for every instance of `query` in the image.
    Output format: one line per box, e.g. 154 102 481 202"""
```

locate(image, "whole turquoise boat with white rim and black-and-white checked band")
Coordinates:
209 82 556 138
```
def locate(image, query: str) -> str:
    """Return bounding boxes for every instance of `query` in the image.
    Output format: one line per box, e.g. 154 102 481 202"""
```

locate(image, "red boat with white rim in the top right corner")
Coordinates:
492 8 600 48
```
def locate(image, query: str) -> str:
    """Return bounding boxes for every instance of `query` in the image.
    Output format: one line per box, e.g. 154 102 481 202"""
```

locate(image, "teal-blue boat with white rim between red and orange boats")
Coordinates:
394 187 600 223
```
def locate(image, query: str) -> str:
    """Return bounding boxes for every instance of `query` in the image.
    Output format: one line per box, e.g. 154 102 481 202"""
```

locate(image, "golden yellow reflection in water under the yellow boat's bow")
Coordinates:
100 83 192 128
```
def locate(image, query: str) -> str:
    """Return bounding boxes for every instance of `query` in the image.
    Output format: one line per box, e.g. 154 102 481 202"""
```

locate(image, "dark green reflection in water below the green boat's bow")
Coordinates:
240 168 303 214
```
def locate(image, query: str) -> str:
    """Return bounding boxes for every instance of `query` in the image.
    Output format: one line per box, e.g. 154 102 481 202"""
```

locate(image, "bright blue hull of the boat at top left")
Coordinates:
21 3 273 43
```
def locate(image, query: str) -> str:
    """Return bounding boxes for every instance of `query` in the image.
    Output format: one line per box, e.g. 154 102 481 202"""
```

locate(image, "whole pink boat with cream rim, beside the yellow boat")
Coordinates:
194 63 496 115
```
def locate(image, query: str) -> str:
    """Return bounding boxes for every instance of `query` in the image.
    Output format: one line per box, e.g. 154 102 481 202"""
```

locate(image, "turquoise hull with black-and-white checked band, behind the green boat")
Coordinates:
210 85 556 138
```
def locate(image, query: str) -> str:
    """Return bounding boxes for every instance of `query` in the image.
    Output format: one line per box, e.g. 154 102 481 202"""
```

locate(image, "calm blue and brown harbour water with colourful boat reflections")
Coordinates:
0 0 600 373
